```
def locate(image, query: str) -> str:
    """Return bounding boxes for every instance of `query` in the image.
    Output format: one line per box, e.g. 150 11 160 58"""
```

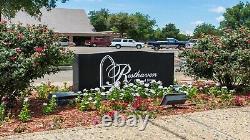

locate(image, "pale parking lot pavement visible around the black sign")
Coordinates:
35 47 192 85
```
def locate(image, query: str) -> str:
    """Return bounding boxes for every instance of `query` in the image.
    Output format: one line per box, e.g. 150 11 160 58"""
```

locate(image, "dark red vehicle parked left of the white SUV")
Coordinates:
84 38 111 47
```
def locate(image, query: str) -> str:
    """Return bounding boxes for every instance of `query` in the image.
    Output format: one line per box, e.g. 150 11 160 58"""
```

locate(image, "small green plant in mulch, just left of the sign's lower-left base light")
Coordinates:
43 95 57 115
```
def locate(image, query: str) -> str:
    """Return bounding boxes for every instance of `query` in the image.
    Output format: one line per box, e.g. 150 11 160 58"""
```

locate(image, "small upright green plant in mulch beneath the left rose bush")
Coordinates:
18 98 31 122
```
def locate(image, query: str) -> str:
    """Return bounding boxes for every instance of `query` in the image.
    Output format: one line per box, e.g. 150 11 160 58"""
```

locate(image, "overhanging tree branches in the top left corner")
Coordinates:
0 0 67 21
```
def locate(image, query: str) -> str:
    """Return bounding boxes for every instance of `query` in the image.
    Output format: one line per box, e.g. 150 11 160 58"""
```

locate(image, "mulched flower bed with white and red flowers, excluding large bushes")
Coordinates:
0 80 250 136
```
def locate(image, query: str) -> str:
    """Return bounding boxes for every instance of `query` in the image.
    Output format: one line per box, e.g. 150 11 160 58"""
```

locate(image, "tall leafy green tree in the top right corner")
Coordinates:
220 2 250 29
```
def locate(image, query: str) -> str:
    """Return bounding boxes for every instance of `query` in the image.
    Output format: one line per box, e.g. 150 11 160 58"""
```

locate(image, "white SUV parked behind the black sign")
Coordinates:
110 38 144 49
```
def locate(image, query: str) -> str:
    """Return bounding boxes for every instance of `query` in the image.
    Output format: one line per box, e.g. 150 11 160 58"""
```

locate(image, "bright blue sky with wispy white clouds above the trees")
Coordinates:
58 0 247 33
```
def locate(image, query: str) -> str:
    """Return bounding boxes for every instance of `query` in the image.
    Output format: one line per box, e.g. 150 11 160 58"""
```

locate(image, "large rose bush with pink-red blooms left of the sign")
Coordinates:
0 22 72 107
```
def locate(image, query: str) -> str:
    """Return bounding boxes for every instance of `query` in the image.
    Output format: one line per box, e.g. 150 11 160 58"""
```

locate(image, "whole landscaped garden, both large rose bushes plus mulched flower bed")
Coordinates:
0 17 250 136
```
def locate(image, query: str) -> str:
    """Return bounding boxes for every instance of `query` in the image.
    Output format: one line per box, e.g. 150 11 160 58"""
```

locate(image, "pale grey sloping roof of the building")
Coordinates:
4 8 94 34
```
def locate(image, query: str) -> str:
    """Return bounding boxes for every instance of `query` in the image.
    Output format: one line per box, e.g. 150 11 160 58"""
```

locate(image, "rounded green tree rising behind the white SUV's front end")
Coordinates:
128 12 156 41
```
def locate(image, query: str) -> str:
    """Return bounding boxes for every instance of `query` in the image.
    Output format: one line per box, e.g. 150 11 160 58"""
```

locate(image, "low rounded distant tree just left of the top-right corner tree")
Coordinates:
194 23 220 38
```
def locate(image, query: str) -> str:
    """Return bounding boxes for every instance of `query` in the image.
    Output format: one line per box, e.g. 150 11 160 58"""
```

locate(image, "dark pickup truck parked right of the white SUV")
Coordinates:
148 38 187 51
